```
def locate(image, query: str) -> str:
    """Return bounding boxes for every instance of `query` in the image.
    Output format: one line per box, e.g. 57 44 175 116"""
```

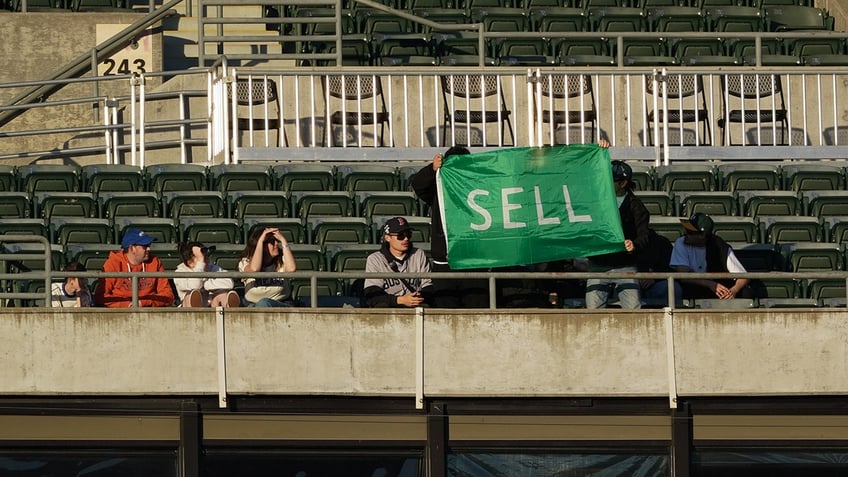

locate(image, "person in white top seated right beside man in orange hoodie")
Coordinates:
174 242 241 308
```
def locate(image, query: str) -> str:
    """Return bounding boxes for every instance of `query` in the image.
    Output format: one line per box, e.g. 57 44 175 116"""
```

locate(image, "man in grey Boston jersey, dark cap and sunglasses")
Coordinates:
364 217 433 308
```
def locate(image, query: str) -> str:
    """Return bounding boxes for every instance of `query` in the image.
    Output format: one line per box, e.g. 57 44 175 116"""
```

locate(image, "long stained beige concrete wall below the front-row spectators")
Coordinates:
0 308 848 398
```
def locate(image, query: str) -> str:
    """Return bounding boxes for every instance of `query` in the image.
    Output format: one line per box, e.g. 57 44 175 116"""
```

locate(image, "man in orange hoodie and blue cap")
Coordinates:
94 229 174 308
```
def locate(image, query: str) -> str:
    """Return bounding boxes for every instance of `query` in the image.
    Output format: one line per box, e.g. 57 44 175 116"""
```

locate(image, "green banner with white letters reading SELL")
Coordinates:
437 144 624 269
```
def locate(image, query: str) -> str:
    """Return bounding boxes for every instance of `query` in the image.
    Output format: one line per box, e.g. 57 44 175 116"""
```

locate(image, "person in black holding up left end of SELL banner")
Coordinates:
410 146 489 308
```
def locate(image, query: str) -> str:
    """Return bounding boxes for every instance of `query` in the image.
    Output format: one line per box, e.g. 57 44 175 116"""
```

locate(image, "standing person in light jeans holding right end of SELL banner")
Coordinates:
586 160 651 308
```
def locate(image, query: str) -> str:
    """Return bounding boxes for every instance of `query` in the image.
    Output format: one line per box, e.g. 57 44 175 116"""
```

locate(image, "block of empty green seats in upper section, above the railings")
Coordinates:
283 1 848 66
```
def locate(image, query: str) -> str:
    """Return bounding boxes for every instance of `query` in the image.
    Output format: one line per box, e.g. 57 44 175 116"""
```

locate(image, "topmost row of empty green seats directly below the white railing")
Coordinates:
0 160 848 197
